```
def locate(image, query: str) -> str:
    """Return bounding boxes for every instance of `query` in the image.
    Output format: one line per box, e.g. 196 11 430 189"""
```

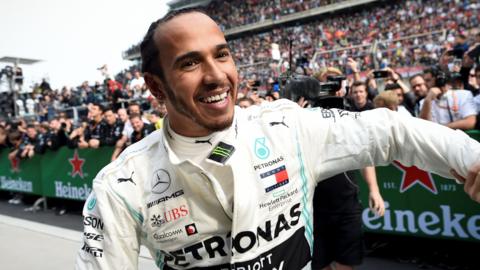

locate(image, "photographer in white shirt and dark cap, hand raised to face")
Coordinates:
420 69 477 130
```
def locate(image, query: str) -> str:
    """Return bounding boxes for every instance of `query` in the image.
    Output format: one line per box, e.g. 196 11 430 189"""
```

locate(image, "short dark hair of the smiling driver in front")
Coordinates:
140 7 208 79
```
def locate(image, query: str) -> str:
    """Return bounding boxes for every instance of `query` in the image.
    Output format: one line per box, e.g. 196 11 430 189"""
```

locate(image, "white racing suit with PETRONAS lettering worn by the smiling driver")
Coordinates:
76 100 480 270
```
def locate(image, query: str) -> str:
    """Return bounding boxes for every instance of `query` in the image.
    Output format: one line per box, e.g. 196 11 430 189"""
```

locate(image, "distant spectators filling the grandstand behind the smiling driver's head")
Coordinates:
123 0 480 83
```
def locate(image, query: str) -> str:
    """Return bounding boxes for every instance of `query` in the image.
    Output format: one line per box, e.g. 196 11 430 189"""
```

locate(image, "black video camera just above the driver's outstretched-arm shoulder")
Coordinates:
283 75 349 109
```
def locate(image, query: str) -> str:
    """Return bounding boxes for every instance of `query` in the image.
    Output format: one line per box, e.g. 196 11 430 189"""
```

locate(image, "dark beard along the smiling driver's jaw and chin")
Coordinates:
163 81 233 132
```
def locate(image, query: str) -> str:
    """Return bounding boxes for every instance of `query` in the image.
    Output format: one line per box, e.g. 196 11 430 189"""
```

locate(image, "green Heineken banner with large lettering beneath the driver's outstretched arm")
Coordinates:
359 131 480 242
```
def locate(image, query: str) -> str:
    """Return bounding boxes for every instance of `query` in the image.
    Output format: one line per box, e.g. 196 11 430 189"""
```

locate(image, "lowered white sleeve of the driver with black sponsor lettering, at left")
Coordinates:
75 179 142 270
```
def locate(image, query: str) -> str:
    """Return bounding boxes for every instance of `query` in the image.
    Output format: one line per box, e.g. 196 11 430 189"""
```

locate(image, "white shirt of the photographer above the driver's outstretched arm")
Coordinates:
420 90 477 125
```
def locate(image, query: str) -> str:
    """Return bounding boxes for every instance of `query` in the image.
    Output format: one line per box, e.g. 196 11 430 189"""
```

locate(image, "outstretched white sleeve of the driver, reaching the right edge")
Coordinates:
299 109 480 180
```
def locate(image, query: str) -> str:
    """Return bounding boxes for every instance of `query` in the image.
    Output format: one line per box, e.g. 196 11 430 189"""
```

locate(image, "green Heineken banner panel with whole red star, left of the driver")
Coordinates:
41 147 113 200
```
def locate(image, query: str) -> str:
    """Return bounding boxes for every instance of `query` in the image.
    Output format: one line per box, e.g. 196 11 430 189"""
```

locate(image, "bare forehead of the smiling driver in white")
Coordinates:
155 12 226 61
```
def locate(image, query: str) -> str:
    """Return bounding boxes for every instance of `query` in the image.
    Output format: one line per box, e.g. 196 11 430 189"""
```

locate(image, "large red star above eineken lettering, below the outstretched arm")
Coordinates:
393 161 438 194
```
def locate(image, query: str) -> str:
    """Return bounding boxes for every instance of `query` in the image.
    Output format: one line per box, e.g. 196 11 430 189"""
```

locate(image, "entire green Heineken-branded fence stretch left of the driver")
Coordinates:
0 147 113 200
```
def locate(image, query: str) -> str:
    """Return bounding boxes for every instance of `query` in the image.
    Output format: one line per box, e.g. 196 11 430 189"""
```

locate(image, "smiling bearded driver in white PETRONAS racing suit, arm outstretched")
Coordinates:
77 10 480 270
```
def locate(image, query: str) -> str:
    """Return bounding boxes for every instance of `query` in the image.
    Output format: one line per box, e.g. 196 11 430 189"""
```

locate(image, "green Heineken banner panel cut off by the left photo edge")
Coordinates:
0 150 42 195
